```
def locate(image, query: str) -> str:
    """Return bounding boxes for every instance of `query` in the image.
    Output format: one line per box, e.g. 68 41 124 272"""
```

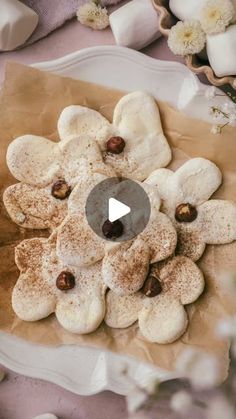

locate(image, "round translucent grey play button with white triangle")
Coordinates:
85 177 151 241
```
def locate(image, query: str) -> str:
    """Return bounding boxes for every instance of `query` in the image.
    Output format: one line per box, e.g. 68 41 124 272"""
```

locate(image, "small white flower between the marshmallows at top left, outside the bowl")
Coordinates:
77 2 109 30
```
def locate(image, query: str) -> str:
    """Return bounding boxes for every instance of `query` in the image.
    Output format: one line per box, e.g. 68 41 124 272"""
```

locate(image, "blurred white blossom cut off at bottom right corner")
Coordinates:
206 395 236 419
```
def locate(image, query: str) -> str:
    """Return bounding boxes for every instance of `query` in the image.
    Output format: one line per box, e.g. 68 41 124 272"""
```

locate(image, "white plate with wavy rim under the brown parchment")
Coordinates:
0 47 229 395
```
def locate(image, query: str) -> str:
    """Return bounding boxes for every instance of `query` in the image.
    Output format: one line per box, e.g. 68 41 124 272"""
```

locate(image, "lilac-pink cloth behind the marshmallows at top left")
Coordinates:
21 0 121 48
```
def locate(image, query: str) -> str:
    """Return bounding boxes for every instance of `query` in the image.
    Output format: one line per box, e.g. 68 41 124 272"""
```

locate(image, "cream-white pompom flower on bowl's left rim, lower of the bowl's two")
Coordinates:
168 20 206 55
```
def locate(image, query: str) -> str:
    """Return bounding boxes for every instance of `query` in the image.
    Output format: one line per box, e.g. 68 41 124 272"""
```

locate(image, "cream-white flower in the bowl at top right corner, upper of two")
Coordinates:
200 0 235 34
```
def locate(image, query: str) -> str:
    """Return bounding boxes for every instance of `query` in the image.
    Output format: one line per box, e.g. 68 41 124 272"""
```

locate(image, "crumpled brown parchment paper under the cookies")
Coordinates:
0 63 236 378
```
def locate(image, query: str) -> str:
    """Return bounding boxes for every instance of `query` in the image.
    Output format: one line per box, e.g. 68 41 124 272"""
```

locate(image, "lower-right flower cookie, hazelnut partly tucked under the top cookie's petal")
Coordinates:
105 256 204 343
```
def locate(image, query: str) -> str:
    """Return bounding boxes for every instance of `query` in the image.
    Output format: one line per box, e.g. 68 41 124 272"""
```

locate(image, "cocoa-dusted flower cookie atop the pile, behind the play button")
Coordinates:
57 174 177 294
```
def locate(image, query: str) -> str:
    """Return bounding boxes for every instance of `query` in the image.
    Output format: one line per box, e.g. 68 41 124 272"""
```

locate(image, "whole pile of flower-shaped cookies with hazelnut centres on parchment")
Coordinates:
3 92 236 344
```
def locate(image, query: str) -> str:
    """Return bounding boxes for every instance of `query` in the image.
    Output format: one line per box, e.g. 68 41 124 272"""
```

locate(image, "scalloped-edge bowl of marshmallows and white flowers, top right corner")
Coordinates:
153 0 236 89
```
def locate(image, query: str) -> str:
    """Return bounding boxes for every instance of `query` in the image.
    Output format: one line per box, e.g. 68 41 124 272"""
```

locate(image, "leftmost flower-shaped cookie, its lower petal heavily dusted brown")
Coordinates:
3 135 114 229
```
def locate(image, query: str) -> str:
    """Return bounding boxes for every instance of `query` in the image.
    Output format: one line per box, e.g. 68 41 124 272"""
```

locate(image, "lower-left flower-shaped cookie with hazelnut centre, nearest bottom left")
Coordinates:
12 233 106 334
